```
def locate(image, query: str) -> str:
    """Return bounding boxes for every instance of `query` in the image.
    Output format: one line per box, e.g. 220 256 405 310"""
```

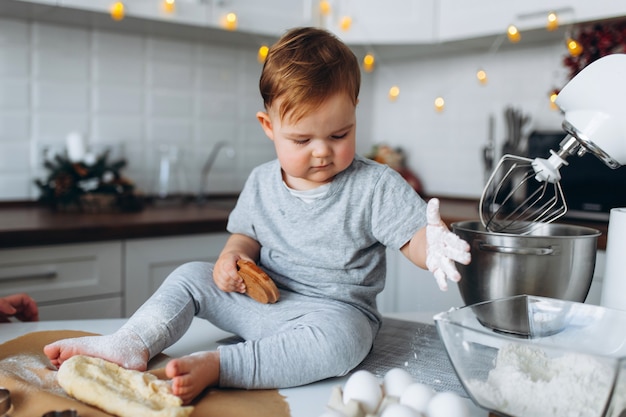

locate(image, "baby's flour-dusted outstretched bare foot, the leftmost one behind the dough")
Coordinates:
43 332 150 371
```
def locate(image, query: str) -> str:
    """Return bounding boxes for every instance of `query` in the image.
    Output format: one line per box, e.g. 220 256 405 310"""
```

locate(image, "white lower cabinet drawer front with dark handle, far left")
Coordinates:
0 241 123 320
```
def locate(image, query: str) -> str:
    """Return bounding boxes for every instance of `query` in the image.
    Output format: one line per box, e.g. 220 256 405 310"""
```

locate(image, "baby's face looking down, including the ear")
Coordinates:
257 94 356 190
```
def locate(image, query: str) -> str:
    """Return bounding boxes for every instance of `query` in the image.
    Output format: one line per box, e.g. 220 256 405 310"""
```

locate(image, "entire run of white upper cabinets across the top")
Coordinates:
0 0 626 48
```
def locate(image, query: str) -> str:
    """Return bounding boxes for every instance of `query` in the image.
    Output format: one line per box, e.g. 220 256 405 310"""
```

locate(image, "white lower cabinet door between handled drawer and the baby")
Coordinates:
124 233 229 316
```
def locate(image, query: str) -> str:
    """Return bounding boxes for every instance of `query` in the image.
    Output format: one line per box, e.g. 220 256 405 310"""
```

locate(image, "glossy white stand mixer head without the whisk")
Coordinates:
556 54 626 168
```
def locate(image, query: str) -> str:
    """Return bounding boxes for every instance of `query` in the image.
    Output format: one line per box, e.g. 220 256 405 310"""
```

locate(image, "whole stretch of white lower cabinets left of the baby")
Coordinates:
0 233 228 320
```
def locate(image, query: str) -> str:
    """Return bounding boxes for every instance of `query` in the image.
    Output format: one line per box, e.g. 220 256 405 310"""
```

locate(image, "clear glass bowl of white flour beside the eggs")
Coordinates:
435 295 626 417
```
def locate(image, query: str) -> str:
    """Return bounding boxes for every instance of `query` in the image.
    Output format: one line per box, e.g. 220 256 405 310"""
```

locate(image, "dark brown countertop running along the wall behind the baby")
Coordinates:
0 197 608 249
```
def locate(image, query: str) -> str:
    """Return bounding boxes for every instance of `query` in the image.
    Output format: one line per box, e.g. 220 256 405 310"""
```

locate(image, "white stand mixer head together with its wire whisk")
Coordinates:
479 54 626 235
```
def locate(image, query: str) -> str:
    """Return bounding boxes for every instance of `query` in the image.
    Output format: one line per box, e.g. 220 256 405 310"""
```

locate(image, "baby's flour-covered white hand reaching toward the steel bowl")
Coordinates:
426 198 471 291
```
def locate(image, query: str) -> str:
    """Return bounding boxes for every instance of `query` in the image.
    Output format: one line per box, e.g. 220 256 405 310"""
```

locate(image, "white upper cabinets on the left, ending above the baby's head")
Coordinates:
0 0 313 38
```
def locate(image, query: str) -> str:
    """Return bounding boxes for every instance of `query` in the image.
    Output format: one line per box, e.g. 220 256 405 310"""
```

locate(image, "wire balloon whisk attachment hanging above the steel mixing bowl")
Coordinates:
480 135 577 235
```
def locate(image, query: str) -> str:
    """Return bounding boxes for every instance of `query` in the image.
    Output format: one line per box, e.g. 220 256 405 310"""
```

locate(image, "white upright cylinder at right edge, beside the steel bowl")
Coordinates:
600 207 626 310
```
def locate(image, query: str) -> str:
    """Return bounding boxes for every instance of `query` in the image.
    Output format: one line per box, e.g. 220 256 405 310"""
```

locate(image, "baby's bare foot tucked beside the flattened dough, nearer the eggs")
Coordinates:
165 351 220 404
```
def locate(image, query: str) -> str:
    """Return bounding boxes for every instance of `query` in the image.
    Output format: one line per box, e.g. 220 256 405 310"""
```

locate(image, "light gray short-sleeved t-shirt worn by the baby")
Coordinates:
227 156 426 321
